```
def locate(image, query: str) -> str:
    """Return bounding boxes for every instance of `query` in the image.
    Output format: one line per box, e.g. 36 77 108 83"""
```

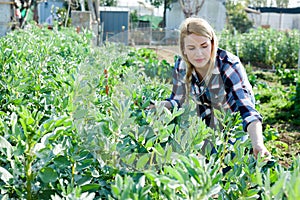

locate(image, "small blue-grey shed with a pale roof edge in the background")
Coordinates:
100 7 130 45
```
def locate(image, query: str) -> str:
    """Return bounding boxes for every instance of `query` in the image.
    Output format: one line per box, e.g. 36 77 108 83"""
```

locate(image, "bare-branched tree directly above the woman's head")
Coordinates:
179 0 205 18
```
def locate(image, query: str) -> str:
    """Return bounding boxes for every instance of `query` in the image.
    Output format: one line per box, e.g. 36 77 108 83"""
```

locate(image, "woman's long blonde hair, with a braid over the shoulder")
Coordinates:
179 17 218 102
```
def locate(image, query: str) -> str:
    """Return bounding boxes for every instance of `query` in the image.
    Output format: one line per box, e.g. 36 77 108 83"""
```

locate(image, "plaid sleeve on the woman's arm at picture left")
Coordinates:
166 58 186 107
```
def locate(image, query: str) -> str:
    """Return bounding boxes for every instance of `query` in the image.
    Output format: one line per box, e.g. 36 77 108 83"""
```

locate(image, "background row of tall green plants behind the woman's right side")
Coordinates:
219 28 300 69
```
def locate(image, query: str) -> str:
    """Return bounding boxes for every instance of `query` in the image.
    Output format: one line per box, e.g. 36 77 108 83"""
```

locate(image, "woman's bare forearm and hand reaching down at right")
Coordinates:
247 120 271 158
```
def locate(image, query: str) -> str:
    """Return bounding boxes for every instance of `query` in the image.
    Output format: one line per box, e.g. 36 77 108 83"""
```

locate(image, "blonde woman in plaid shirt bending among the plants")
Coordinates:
150 18 270 157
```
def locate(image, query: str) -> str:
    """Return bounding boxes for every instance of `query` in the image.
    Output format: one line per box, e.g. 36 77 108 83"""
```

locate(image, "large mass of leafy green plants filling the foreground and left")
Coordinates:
0 26 300 199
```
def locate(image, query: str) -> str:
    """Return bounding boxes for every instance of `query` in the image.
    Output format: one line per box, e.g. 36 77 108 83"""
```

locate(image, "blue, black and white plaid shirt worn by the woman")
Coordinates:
166 49 262 131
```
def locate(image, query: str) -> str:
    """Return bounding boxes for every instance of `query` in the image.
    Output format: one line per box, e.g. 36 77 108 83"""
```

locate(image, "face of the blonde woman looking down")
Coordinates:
183 33 212 72
